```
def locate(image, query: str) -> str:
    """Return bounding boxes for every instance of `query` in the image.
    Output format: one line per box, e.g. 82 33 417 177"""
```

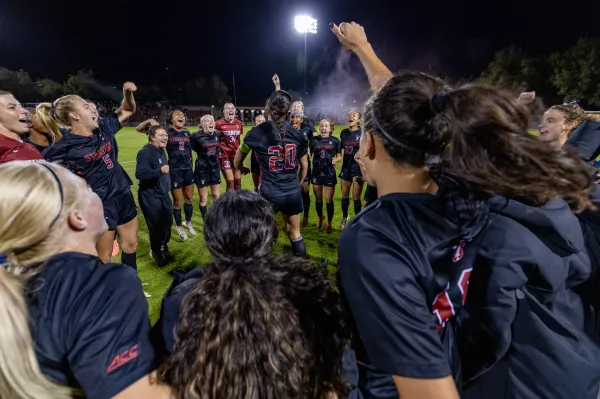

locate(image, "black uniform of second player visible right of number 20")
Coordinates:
310 136 340 187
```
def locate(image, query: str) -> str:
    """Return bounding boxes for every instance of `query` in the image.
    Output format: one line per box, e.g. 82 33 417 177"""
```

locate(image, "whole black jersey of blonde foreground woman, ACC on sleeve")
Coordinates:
25 252 155 399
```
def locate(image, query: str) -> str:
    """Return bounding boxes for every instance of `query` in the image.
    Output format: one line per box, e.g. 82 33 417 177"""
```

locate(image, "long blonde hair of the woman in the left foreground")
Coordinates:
0 161 77 399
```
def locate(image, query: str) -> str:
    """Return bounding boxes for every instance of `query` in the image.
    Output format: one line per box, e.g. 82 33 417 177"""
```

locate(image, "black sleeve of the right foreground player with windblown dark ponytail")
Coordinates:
339 220 451 379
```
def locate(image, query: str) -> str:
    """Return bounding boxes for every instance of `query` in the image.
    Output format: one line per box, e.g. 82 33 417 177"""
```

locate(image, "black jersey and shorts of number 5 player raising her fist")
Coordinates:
44 114 137 230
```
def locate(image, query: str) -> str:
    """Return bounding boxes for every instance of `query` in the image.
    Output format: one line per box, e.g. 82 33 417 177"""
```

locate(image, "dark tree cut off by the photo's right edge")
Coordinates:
549 37 600 106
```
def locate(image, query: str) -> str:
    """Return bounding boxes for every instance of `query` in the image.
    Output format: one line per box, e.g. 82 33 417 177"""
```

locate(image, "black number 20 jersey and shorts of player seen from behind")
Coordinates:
242 123 307 216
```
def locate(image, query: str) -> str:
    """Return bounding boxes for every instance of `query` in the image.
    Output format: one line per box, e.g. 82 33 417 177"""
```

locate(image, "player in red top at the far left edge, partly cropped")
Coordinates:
0 90 43 163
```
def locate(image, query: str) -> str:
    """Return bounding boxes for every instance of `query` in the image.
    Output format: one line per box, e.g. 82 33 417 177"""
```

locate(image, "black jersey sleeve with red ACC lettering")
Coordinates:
68 265 154 399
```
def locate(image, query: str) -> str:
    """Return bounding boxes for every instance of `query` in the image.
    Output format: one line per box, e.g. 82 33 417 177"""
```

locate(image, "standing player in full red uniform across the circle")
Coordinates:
215 103 244 191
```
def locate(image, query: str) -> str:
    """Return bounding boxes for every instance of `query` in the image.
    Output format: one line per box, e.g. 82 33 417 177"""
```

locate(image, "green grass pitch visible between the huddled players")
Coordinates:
115 126 352 323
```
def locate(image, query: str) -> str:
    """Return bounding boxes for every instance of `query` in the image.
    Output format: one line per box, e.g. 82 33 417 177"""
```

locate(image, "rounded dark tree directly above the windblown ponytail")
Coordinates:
479 45 537 92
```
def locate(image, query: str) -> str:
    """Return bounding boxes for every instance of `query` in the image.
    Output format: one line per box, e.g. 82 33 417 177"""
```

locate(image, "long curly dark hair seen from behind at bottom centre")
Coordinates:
158 191 347 399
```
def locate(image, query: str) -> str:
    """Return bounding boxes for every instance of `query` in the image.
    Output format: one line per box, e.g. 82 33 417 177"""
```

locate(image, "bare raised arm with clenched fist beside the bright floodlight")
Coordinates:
329 22 392 92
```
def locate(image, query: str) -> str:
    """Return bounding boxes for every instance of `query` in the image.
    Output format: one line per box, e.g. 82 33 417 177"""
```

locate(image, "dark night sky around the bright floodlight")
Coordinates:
0 0 600 105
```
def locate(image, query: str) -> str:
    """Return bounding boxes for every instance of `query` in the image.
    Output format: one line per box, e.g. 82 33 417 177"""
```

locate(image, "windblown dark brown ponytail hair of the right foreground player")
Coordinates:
364 72 593 209
